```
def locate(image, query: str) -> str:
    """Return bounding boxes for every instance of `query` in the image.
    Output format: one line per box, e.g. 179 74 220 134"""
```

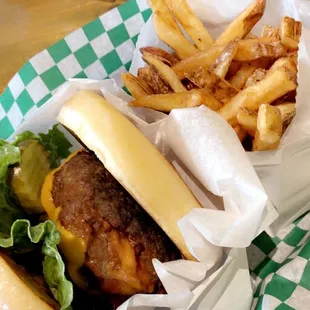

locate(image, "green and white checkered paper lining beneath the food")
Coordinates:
0 0 310 310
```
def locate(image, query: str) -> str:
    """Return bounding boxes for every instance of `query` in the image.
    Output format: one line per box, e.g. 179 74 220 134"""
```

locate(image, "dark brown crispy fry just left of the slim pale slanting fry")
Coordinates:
138 67 171 94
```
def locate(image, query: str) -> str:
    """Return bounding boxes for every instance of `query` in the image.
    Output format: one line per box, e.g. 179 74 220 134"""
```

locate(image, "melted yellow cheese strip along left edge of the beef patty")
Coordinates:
41 152 86 288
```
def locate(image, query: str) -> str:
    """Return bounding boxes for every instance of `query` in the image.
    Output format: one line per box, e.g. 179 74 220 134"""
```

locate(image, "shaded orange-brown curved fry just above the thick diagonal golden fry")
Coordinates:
228 59 269 89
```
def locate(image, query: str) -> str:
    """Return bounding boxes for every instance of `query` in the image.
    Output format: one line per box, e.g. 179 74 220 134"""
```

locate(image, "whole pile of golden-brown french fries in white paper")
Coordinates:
122 0 302 151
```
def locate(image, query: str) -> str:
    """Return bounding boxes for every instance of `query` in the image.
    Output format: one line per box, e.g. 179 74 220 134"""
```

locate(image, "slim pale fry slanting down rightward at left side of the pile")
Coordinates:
142 52 186 93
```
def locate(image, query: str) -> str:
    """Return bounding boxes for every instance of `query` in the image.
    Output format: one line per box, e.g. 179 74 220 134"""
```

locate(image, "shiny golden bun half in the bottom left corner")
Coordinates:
0 254 59 310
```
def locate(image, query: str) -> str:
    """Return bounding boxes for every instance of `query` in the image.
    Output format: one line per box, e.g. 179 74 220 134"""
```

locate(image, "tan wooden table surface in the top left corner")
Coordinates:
0 0 126 94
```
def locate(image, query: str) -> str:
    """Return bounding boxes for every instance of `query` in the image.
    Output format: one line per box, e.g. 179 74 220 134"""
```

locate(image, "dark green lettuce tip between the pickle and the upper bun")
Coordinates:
39 125 72 168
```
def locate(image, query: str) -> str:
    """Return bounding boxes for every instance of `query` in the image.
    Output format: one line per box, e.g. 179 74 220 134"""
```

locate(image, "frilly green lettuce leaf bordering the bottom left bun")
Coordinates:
0 220 73 309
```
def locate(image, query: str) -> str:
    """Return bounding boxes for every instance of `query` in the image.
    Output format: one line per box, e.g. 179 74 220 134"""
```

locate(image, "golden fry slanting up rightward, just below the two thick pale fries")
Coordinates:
173 44 226 80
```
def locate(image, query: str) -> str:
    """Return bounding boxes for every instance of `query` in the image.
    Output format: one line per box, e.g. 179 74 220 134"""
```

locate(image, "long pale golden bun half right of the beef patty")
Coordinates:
58 91 200 260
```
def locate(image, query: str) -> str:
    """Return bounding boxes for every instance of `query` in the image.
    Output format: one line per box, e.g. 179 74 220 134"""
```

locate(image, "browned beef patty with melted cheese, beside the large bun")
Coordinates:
52 151 181 295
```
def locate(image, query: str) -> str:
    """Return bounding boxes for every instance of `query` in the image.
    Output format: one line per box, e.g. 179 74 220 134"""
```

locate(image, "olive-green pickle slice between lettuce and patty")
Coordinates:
10 140 51 213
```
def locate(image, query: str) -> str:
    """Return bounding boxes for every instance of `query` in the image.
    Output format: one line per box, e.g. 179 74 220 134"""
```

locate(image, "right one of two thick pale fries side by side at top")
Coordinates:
165 0 213 50
